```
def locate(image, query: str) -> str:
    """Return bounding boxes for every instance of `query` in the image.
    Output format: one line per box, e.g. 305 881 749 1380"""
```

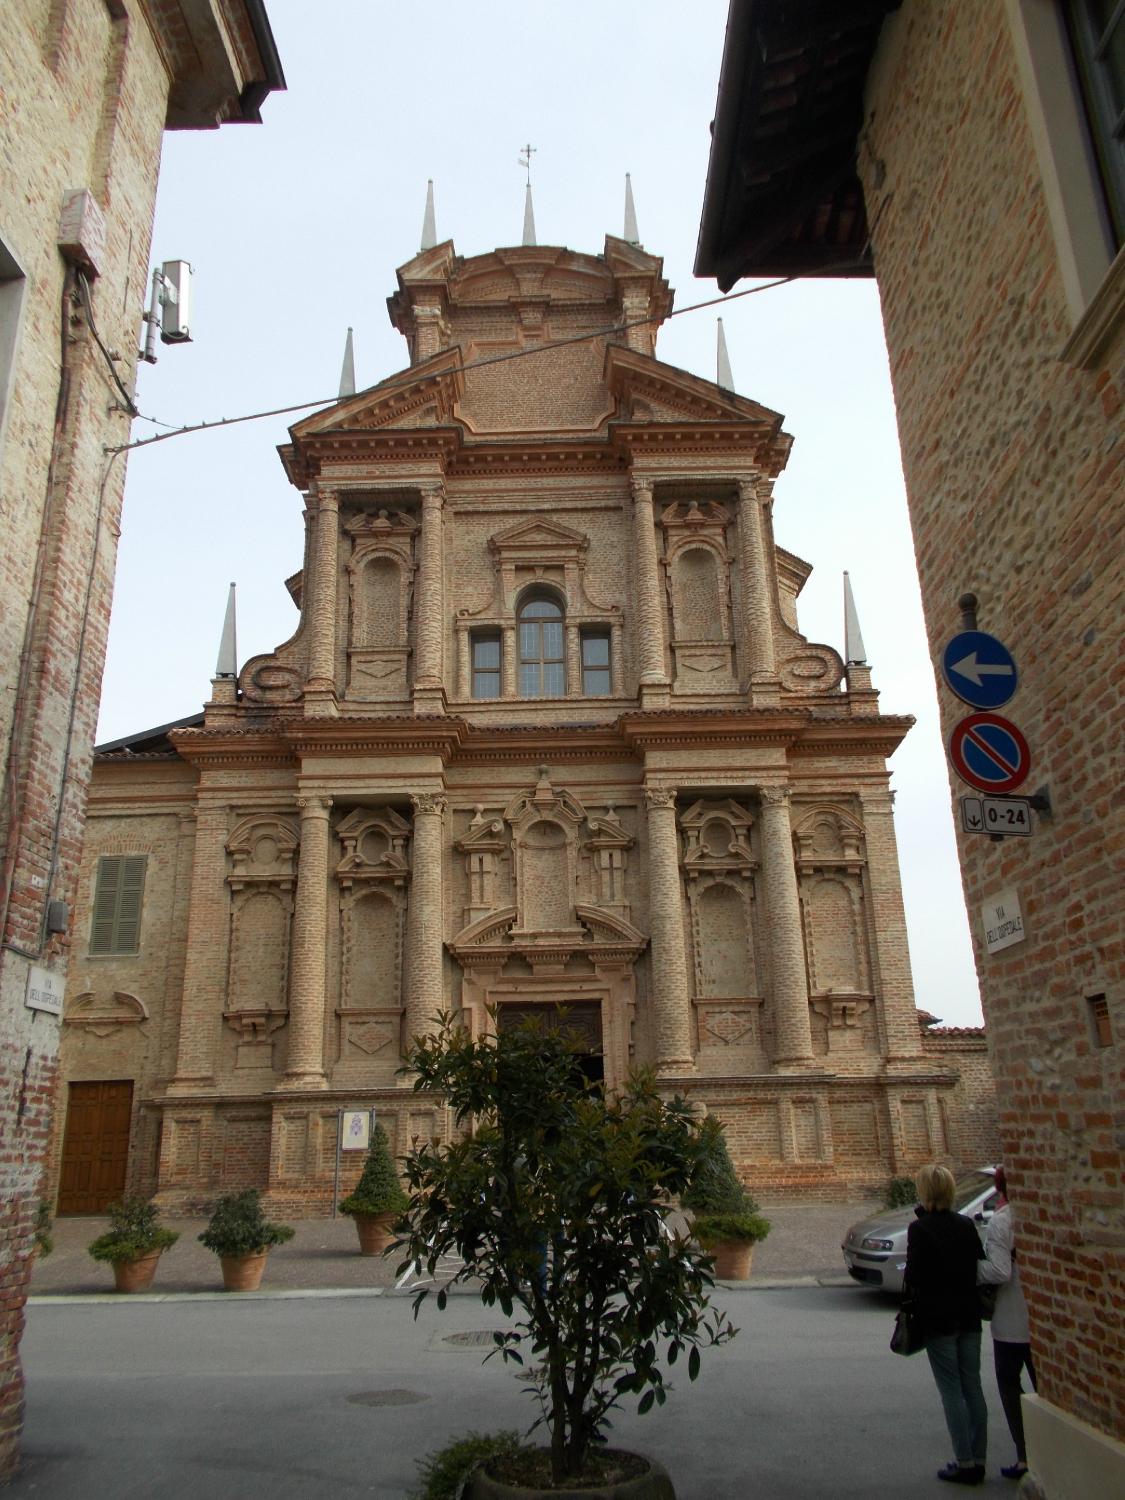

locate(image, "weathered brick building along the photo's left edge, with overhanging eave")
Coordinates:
0 0 284 1479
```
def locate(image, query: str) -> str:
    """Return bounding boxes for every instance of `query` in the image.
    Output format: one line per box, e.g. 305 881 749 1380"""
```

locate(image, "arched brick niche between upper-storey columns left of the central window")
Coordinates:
344 510 419 702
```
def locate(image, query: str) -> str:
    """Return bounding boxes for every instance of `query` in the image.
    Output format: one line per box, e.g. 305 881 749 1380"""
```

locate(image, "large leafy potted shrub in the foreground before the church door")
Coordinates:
401 1016 735 1500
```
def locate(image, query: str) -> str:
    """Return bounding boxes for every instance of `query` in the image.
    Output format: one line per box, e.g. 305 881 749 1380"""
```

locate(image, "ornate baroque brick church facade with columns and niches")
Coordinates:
48 228 993 1212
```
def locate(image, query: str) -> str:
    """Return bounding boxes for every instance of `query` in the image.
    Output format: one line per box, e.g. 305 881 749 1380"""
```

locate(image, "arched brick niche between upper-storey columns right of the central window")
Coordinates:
660 500 737 693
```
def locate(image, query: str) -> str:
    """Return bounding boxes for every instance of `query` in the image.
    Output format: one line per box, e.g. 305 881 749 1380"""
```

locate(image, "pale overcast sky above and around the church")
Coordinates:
99 0 980 1025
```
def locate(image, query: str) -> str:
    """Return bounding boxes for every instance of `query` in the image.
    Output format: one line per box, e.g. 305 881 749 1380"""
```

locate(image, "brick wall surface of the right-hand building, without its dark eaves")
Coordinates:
860 0 1125 1434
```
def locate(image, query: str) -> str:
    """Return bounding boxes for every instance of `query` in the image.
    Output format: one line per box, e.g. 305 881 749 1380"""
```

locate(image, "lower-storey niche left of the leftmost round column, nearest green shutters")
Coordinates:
224 813 299 1070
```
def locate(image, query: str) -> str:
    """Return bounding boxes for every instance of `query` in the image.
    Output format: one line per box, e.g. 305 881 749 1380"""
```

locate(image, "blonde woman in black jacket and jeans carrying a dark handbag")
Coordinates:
905 1166 989 1485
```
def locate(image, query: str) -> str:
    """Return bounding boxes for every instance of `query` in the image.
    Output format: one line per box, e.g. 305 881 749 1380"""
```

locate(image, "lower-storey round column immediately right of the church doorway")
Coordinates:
645 788 695 1074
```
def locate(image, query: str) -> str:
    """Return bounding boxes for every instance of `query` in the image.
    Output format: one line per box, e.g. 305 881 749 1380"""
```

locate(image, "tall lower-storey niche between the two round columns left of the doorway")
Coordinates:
336 807 411 1065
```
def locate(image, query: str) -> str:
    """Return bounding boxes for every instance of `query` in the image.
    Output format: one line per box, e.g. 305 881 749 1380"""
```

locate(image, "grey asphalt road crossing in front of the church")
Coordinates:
9 1287 1013 1500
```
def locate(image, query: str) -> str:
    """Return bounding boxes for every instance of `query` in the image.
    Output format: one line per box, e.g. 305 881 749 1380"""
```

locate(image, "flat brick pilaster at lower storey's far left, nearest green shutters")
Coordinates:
168 803 230 1095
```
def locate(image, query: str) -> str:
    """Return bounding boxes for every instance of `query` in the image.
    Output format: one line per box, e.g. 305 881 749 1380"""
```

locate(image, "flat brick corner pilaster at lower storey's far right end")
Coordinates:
860 788 923 1068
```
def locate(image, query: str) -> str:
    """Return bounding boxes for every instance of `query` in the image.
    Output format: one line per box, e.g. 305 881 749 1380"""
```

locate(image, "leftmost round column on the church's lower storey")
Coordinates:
281 797 332 1089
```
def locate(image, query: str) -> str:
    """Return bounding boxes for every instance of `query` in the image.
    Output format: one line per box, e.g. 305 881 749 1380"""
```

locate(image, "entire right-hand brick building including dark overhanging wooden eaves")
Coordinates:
696 0 1125 1500
